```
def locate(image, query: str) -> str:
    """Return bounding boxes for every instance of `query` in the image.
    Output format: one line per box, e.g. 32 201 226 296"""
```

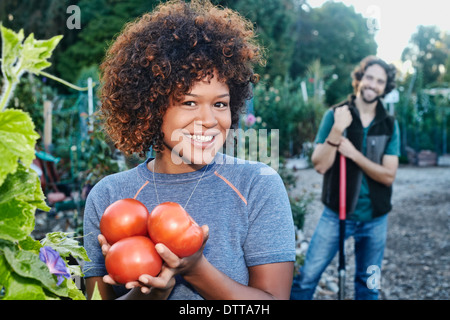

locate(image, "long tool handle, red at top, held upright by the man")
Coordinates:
338 154 347 300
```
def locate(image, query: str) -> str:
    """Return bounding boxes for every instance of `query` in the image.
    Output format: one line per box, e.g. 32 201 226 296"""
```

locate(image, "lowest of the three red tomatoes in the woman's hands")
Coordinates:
105 236 162 284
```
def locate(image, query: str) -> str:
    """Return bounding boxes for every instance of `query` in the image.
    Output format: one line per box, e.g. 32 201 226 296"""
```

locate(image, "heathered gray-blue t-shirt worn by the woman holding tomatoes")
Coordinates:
83 153 295 300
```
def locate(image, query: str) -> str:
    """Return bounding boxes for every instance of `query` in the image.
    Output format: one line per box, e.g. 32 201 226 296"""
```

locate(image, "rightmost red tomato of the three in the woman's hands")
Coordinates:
148 202 203 258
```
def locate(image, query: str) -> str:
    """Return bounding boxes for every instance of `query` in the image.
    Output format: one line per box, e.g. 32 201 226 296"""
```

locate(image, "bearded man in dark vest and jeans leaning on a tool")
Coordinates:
291 56 399 300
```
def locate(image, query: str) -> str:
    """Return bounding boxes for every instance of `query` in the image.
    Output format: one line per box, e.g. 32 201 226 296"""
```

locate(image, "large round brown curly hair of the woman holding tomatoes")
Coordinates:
100 0 264 156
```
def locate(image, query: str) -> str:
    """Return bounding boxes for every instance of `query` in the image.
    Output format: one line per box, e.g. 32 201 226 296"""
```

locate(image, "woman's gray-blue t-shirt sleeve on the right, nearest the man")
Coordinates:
244 166 295 267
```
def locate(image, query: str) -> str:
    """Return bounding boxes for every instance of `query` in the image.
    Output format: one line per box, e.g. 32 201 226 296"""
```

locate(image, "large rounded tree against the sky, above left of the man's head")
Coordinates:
290 2 377 104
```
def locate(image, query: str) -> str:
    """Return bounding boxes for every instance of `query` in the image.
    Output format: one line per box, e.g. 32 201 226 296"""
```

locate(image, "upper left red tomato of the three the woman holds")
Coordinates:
100 199 149 244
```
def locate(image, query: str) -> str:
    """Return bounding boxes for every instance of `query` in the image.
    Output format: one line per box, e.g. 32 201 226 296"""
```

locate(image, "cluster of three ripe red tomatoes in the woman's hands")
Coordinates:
100 198 203 284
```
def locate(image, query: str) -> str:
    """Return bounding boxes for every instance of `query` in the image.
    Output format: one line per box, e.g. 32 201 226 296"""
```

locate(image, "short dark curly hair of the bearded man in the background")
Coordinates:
352 56 397 97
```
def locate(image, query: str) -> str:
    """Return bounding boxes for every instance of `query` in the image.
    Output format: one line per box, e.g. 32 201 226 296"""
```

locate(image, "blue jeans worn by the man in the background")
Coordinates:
291 207 387 300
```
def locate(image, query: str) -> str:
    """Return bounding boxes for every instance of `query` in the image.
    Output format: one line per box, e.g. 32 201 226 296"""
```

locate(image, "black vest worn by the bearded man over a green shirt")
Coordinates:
322 96 394 218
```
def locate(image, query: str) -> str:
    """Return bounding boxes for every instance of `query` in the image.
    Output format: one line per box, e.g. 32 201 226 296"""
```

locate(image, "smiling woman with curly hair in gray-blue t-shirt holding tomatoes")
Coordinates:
84 1 295 299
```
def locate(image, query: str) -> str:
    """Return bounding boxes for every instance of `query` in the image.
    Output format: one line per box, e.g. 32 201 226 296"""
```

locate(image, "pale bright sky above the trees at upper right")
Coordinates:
308 0 450 63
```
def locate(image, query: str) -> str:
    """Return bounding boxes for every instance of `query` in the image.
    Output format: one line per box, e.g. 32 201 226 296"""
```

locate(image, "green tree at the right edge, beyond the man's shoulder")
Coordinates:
398 26 450 154
